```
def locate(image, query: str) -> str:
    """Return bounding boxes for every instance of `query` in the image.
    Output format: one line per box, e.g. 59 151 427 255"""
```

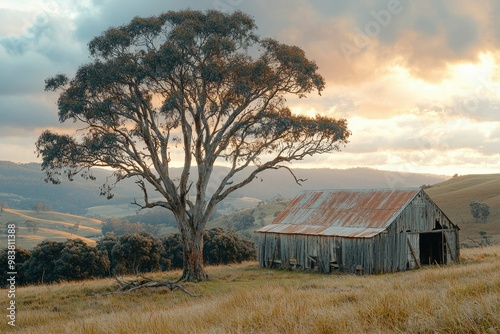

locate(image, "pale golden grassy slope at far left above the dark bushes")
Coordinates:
0 209 101 249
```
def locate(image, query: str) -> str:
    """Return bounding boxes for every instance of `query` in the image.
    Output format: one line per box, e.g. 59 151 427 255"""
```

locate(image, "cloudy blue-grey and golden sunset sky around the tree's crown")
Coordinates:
0 0 500 176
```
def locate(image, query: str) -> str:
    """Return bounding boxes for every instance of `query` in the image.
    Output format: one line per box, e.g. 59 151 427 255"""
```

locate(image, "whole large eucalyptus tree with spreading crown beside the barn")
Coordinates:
36 10 350 281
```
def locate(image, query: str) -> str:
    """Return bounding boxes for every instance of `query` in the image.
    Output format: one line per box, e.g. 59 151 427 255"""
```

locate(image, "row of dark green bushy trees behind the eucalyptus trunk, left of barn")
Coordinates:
0 228 256 287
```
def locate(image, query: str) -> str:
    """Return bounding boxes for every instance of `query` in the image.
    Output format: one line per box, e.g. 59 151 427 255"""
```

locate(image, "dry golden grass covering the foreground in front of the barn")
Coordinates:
0 246 500 334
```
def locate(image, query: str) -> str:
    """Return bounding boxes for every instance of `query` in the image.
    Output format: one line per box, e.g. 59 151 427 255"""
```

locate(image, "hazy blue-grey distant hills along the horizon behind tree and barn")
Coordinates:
0 161 446 216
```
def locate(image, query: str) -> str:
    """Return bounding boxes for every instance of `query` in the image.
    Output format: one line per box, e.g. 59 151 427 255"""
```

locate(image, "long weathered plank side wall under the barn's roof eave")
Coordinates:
259 233 407 274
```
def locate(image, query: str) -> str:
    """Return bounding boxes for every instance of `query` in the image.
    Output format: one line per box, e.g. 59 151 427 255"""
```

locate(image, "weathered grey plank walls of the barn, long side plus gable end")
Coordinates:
259 191 459 274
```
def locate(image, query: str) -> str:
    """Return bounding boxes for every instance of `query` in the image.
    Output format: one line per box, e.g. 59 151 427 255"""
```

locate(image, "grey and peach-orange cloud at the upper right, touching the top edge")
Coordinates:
249 0 498 82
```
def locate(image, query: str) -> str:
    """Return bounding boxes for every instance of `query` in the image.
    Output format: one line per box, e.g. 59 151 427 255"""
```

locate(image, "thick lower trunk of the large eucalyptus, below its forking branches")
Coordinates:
180 231 208 282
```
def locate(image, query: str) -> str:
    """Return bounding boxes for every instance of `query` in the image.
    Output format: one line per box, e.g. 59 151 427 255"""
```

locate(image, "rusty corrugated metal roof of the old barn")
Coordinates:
257 188 421 238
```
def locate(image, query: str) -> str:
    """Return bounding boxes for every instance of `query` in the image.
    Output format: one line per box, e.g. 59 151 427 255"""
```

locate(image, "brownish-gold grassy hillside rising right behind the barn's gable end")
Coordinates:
425 174 500 244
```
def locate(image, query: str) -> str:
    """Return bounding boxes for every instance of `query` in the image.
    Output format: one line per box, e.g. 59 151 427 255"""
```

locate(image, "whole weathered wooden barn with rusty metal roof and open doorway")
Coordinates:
257 188 460 274
